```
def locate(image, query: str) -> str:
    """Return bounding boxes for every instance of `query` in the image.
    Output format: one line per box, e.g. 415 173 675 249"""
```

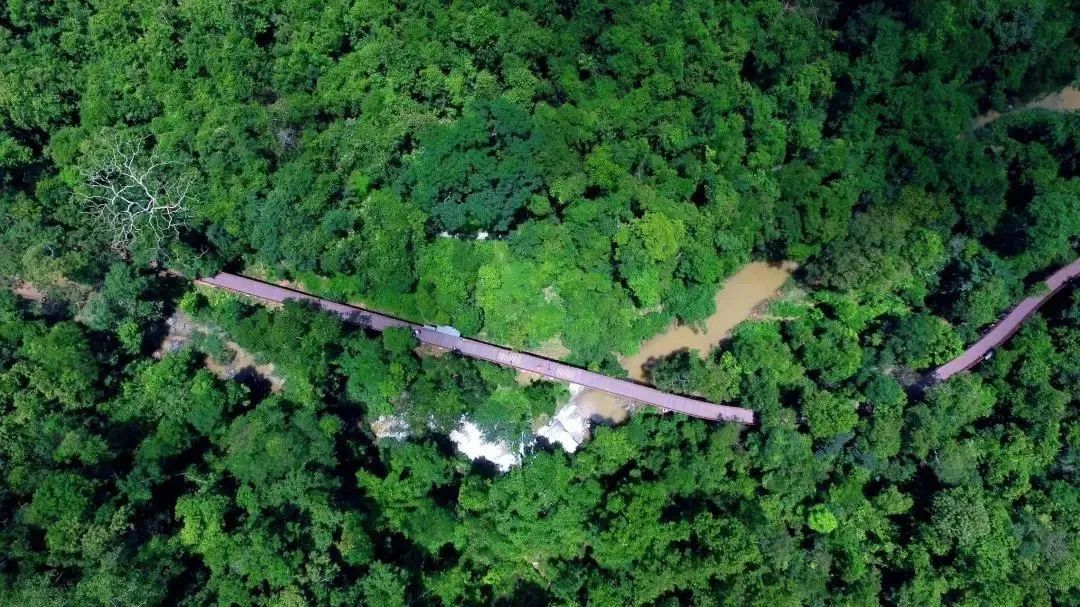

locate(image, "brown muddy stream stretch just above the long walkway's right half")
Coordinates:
620 261 795 381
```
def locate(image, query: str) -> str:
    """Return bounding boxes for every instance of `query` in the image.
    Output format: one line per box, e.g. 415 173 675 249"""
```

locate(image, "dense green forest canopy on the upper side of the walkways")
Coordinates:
8 2 1080 364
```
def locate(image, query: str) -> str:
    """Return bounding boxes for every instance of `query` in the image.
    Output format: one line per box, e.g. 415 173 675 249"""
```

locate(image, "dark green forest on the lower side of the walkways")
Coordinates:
6 272 1080 605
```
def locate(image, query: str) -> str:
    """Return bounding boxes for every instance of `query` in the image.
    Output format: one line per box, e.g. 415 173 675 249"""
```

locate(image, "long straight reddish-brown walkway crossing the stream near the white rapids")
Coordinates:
198 273 754 423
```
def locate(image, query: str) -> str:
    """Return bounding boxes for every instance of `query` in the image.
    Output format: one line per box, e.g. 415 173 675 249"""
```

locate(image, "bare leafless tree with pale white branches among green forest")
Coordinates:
79 135 193 252
